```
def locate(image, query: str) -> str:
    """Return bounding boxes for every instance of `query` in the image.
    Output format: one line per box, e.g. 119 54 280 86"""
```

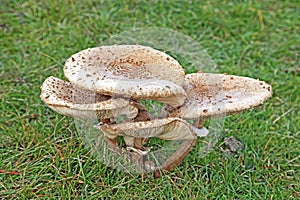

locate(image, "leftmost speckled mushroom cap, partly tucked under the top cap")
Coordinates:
40 76 138 120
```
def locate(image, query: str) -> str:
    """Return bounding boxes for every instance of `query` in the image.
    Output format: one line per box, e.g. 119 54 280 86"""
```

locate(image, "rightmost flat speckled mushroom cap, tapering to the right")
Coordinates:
169 73 272 119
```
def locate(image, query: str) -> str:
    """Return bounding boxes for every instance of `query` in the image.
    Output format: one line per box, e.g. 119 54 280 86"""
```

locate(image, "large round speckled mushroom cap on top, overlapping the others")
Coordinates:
64 45 186 107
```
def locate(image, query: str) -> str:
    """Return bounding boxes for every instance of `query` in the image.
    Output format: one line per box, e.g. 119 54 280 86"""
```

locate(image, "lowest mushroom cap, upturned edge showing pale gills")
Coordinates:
101 117 208 140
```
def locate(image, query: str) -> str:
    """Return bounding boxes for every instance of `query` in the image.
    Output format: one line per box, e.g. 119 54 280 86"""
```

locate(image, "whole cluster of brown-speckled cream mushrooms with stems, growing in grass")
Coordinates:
41 45 272 176
